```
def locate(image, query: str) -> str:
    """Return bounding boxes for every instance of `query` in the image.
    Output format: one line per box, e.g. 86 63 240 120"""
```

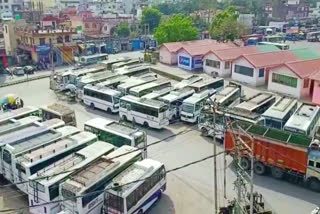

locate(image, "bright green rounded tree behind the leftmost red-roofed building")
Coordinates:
154 14 198 44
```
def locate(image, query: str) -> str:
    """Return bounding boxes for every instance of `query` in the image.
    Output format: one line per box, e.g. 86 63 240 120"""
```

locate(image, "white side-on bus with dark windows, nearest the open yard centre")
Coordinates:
120 95 169 129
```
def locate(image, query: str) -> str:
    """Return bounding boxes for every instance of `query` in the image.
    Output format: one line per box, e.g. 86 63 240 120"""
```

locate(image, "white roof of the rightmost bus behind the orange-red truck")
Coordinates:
284 103 319 131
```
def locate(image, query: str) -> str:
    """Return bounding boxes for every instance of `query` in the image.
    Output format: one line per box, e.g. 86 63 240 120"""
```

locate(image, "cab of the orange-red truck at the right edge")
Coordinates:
306 139 320 192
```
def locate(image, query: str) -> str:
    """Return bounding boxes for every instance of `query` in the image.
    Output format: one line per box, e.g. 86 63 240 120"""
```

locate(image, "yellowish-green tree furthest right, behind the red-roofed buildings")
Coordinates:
210 7 243 41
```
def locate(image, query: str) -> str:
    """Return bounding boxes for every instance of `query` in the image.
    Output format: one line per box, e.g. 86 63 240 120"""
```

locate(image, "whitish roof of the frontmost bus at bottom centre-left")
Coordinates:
106 159 163 197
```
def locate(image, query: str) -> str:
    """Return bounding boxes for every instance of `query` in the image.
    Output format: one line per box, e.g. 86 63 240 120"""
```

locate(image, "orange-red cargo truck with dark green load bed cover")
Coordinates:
225 122 320 192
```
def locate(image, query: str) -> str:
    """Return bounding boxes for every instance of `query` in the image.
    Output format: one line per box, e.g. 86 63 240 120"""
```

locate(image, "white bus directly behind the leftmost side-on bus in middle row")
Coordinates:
77 71 117 100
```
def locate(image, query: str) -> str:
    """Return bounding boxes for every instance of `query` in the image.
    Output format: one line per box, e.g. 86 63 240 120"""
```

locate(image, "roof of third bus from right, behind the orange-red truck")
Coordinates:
235 93 275 112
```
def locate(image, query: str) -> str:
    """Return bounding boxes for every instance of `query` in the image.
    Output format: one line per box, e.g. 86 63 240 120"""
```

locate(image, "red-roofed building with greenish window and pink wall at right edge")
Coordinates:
268 59 320 99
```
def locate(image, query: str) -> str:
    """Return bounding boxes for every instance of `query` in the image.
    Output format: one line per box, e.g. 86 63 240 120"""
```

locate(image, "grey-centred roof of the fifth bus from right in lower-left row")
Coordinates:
7 126 80 154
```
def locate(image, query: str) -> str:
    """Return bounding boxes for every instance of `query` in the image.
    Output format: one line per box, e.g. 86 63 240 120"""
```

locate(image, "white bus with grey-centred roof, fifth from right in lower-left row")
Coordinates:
1 126 80 182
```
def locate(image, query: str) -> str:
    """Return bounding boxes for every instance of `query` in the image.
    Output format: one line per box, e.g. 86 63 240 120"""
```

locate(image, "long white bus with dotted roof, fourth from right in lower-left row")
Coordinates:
13 132 97 193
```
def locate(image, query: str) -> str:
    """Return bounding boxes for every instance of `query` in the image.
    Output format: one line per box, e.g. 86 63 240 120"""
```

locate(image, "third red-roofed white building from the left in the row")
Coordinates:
203 45 279 77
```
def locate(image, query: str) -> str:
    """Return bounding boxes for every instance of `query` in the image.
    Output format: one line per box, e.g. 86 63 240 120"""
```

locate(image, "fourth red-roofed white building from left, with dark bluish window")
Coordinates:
232 51 299 86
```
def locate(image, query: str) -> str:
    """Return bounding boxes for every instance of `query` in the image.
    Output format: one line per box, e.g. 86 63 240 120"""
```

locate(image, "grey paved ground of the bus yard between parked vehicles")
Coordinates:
0 76 319 214
